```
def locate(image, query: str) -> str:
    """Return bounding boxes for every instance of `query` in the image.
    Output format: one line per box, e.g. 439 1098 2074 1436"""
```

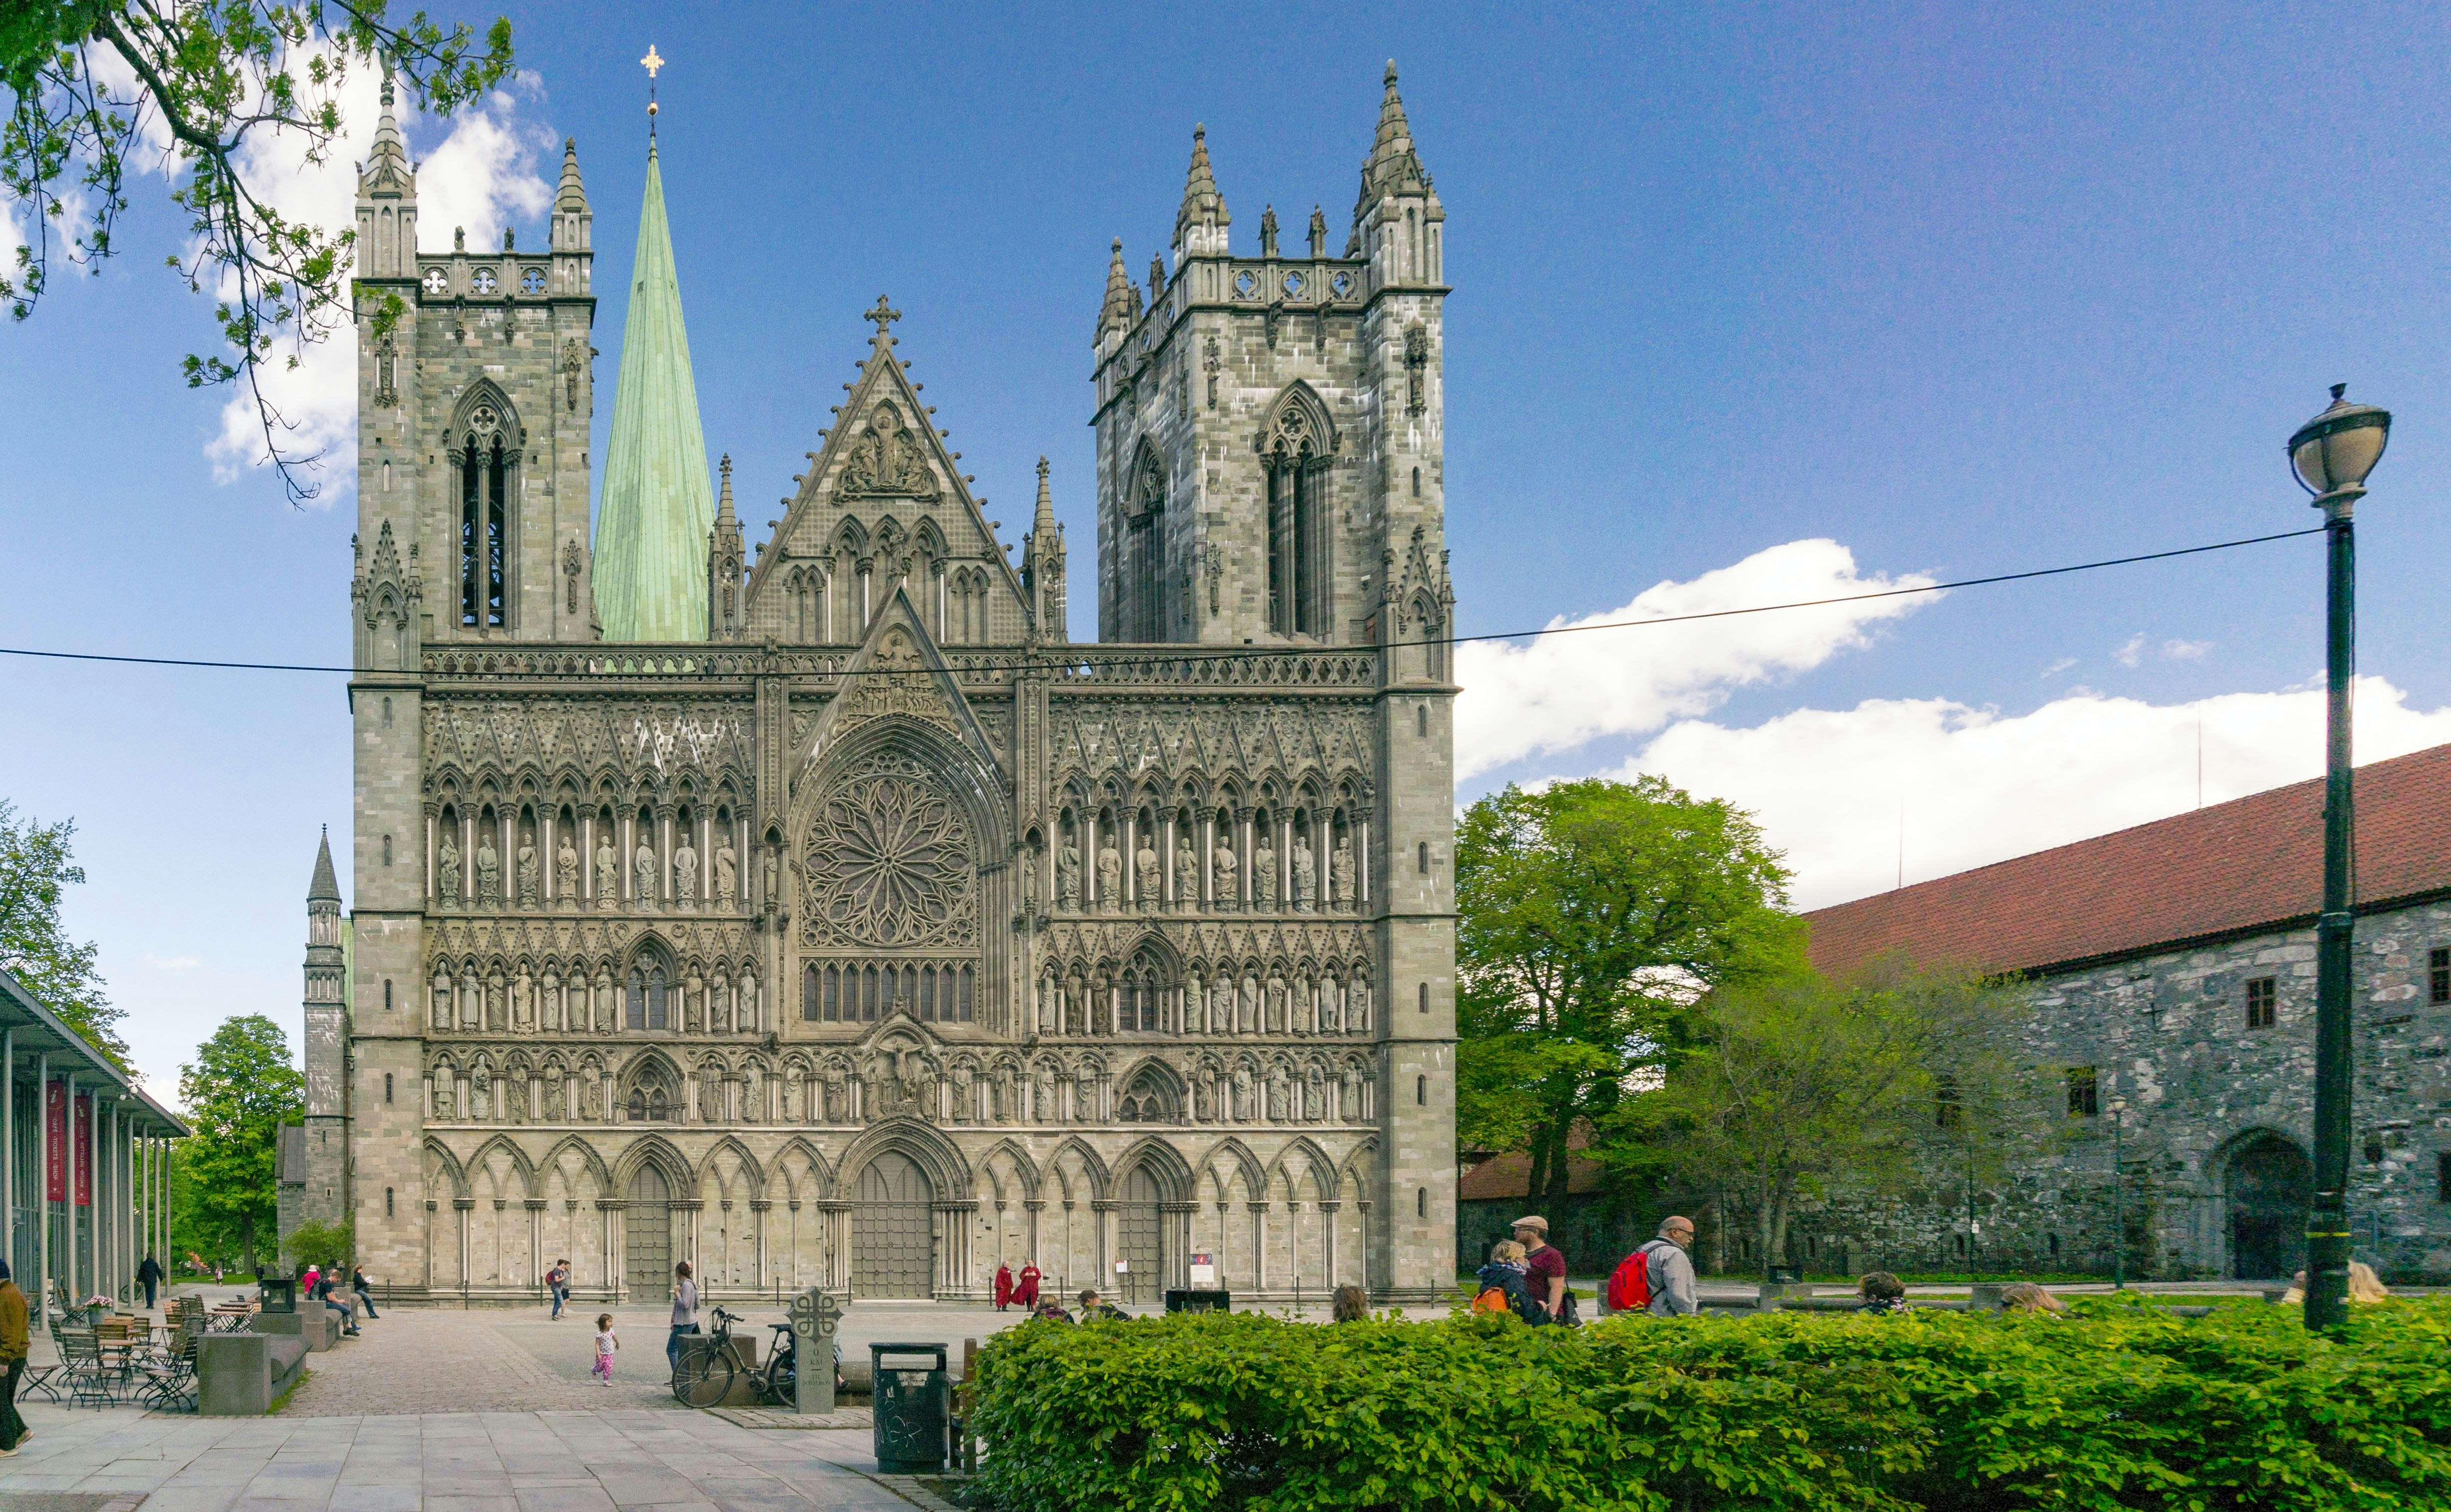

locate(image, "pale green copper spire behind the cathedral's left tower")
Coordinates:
596 135 716 640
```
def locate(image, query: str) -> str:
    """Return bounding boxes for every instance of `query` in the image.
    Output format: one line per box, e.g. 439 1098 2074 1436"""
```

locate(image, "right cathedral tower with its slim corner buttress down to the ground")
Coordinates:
1093 61 1456 1289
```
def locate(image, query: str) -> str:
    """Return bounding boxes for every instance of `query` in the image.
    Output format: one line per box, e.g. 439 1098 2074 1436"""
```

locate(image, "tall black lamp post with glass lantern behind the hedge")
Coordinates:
2289 382 2392 1330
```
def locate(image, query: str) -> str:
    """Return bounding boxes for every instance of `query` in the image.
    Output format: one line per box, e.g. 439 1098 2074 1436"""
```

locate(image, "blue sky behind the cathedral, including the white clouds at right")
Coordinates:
0 5 2451 1083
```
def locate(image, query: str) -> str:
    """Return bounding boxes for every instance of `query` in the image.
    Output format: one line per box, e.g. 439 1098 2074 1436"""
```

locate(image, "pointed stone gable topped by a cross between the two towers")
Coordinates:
745 306 1029 620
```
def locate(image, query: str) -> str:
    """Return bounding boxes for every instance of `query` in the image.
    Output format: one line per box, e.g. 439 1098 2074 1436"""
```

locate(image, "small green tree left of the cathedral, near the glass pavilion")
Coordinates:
179 1015 304 1270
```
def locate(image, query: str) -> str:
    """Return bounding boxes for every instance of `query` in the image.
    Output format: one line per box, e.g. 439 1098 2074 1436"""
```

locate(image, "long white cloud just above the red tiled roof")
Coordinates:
1610 676 2451 909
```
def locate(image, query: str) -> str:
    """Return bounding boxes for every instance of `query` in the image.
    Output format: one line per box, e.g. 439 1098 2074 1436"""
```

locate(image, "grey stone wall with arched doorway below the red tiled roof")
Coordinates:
1730 899 2451 1282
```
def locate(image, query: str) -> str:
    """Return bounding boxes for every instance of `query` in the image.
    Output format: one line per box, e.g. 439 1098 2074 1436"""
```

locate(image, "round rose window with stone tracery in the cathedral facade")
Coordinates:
801 770 978 948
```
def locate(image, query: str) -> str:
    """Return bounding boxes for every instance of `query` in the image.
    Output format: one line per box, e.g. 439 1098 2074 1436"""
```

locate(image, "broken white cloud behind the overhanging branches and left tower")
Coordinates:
133 66 554 502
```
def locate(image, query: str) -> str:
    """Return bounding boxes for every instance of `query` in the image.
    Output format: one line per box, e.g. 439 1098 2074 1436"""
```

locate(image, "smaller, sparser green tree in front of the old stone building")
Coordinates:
1603 961 2037 1267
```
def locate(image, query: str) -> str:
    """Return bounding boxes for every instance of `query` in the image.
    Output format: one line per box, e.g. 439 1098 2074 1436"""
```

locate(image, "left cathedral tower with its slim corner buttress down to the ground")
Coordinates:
343 83 596 1279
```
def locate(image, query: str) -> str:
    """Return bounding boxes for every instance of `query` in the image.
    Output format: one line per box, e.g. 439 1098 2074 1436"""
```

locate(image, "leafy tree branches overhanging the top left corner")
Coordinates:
0 0 512 500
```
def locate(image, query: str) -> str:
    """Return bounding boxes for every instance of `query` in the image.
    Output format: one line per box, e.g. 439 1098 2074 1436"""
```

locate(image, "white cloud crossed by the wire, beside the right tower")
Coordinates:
1456 539 1936 777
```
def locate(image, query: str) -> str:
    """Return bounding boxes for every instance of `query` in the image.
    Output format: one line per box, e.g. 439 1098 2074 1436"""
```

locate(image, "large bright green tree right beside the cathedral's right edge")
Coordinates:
1456 777 1801 1206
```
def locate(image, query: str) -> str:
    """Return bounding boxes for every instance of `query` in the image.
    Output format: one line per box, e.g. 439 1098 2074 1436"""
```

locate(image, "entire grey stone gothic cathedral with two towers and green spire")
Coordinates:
299 66 1456 1303
